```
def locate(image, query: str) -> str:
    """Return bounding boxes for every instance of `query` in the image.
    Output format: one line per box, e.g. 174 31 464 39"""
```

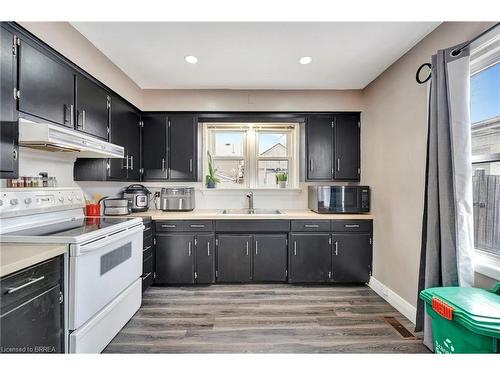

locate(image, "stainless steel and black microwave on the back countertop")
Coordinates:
308 186 370 214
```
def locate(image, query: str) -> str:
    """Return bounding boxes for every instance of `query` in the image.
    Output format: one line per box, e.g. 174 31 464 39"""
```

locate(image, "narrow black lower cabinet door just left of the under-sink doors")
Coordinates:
195 233 215 284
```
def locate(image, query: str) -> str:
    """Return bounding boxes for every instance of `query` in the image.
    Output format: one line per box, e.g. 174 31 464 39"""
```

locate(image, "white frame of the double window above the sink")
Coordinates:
202 122 299 190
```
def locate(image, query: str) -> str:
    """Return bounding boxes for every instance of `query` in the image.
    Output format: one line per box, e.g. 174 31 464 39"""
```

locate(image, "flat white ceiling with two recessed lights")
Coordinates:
72 22 439 89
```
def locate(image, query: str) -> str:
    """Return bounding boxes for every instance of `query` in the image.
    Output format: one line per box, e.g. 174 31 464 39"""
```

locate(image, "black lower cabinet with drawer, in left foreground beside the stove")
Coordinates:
0 256 64 353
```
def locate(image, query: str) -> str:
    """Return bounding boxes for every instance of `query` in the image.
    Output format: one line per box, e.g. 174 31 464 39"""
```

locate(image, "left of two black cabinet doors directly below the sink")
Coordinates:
217 234 252 282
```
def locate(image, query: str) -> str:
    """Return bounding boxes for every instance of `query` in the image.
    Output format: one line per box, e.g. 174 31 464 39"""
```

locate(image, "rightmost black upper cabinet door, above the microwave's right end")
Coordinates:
334 114 360 180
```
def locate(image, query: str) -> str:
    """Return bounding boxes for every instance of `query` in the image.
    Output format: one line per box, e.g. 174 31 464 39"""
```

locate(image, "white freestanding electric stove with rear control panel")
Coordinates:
0 188 144 353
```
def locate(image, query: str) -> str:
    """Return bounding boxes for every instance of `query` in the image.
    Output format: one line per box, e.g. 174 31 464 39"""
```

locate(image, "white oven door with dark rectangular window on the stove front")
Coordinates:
69 225 144 330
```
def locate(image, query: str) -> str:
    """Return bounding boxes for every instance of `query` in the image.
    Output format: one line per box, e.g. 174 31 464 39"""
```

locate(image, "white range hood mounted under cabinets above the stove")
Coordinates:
19 118 124 158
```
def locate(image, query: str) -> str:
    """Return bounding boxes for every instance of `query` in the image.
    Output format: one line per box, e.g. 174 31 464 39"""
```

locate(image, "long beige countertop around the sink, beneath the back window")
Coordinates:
123 209 373 220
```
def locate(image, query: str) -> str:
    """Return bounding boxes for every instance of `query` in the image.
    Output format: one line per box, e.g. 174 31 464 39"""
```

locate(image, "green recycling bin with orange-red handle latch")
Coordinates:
420 283 500 354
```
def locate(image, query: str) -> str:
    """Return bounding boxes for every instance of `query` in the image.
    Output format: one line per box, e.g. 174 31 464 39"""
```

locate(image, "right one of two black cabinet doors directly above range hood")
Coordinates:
75 75 111 140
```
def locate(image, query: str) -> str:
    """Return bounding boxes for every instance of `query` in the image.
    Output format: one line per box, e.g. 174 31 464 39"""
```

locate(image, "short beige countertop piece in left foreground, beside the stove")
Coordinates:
0 243 68 277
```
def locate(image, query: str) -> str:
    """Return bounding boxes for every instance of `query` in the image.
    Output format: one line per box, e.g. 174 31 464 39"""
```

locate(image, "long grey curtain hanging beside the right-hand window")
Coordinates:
416 46 474 350
